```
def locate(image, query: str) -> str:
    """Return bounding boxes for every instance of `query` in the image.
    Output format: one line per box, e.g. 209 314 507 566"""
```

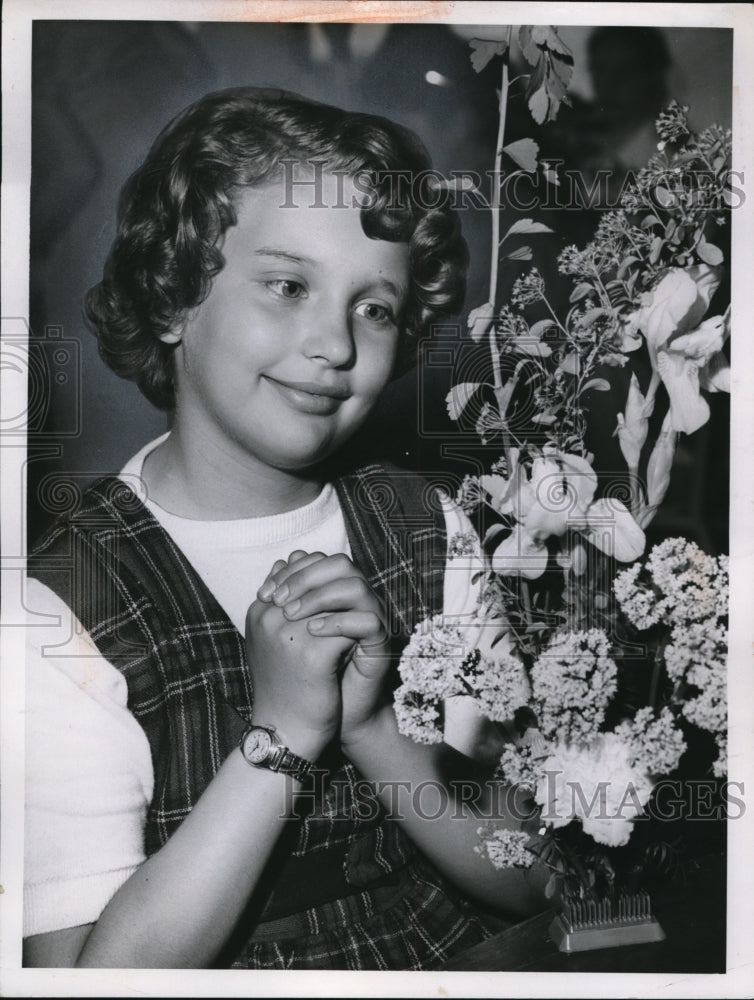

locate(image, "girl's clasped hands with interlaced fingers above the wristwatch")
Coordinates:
246 551 389 757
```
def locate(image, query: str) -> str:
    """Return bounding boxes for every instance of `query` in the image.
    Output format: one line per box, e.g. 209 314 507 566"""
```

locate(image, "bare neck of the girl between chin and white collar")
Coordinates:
142 422 324 520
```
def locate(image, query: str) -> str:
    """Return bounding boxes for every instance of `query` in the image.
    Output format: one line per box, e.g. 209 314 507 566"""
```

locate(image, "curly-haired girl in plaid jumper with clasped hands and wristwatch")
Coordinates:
25 89 541 969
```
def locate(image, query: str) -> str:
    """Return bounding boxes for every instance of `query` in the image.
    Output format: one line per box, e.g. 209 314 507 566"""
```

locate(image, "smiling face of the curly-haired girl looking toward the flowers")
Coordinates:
166 174 409 471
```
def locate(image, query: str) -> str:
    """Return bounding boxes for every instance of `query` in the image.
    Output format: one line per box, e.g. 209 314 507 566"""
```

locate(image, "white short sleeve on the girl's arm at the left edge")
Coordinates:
24 580 153 936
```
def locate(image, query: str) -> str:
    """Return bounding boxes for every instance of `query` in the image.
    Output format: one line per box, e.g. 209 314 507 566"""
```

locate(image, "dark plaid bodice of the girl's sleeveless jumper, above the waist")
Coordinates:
28 465 446 958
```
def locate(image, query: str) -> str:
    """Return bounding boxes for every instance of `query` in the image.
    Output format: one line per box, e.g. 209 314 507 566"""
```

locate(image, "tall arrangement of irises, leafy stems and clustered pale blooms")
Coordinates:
395 26 731 898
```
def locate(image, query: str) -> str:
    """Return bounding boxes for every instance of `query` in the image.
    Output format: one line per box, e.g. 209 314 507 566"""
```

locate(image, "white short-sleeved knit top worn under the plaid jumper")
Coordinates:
24 436 483 936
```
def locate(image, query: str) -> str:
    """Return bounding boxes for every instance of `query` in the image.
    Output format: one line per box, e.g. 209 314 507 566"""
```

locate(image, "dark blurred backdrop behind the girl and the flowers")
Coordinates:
28 21 732 552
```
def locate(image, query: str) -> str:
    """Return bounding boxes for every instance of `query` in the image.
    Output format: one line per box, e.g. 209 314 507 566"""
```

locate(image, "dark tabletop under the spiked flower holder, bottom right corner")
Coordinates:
443 855 726 973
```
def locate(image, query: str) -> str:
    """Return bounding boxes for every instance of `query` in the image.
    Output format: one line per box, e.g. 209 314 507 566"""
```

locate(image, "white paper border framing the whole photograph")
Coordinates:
0 0 754 997
